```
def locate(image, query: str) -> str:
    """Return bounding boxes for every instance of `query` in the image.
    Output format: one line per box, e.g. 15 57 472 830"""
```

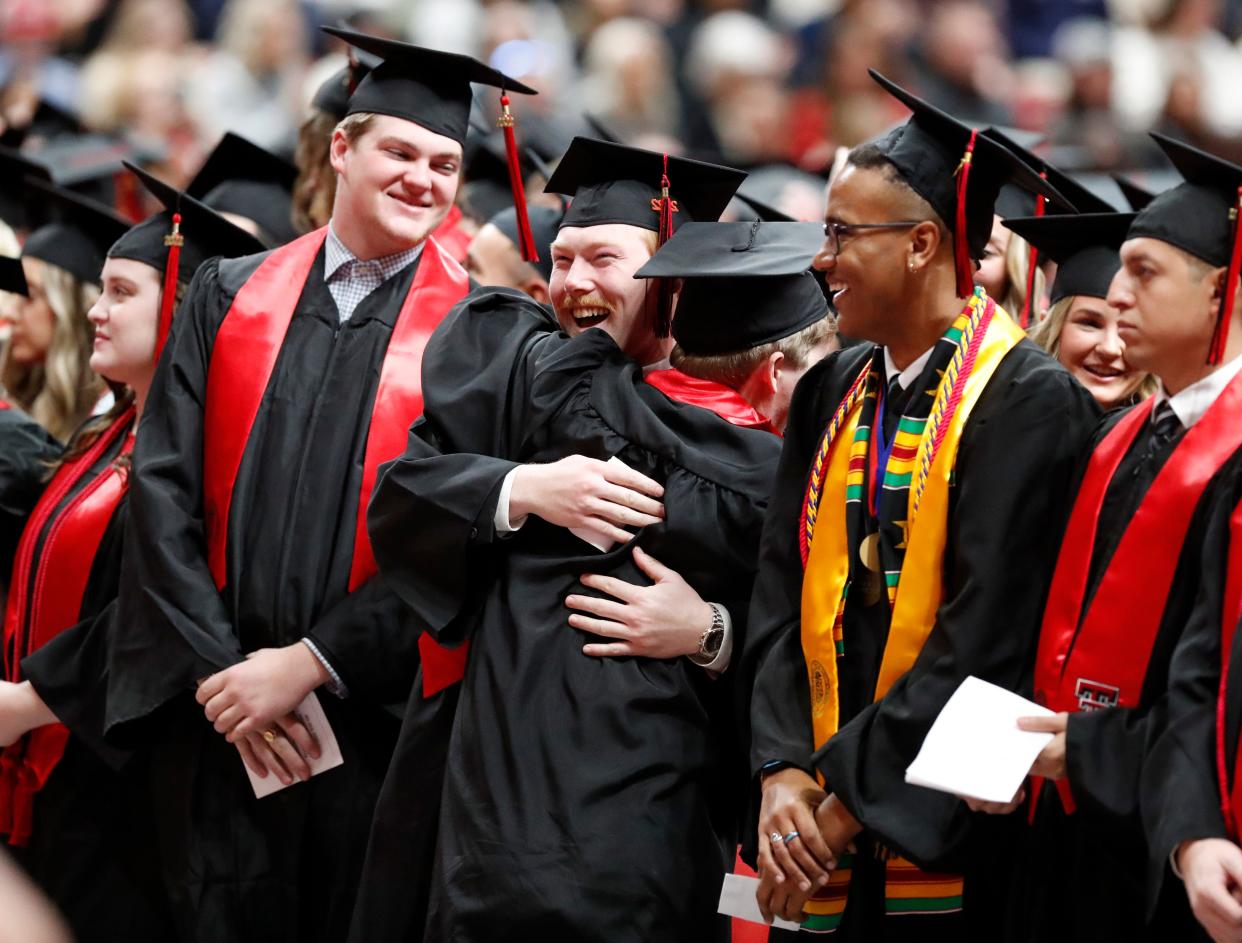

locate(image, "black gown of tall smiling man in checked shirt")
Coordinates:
104 250 427 943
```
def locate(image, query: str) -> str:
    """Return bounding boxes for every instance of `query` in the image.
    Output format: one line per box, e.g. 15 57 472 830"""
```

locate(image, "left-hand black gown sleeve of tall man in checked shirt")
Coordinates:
106 260 242 729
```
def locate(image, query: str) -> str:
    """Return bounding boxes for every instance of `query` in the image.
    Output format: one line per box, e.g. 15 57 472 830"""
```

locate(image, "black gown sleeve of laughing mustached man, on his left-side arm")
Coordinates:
366 289 556 645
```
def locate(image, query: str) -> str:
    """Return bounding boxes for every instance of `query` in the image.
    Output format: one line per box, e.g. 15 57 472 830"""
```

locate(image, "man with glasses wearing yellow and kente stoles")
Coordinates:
750 73 1097 941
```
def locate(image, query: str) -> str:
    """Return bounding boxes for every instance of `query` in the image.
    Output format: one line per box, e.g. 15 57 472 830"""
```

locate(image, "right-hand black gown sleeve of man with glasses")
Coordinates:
816 343 1098 866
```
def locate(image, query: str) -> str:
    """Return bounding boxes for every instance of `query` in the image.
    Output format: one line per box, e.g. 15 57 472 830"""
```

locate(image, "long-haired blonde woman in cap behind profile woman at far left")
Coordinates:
0 178 118 441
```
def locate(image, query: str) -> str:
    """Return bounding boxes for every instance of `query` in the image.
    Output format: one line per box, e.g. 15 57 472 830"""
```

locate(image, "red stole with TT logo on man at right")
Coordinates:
1032 375 1242 813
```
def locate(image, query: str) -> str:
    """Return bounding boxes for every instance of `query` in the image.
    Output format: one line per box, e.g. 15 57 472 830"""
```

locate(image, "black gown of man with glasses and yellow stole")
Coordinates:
743 340 1098 943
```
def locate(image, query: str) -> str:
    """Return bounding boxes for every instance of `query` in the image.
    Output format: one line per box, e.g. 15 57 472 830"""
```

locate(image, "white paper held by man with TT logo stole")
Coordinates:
905 677 1053 803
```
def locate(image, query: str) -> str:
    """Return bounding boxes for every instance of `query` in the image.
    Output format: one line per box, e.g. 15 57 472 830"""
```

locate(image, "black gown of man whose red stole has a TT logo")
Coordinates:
1006 404 1222 943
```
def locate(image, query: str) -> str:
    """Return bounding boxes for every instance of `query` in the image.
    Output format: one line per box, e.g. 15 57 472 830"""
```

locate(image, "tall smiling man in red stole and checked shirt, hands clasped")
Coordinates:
99 30 530 943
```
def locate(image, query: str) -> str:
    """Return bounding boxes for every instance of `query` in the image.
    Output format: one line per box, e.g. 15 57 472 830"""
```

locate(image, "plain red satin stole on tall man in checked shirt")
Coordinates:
202 227 469 697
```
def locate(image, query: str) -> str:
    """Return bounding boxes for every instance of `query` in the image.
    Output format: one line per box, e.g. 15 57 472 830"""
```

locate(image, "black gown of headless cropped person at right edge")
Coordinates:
1139 452 1242 939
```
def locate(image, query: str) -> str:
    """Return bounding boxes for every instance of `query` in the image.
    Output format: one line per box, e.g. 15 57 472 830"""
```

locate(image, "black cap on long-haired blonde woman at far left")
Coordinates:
21 178 129 285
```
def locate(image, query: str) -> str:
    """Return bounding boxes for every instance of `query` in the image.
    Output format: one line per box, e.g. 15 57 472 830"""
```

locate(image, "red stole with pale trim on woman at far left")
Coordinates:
0 406 134 845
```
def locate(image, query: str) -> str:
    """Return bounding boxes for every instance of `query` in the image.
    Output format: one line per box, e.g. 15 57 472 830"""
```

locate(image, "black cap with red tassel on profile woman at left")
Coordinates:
108 163 263 360
